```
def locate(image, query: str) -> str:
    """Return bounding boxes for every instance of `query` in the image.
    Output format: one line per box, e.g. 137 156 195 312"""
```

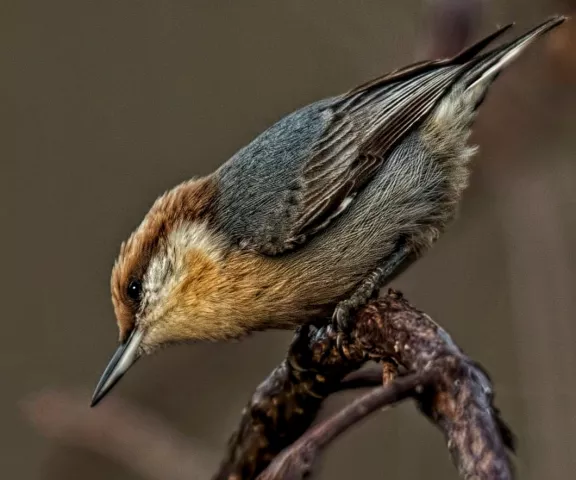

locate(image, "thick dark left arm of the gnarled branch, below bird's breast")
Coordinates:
215 327 366 479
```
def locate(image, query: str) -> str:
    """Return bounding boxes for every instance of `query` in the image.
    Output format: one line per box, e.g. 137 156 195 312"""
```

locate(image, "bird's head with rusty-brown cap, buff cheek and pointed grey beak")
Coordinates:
92 178 252 405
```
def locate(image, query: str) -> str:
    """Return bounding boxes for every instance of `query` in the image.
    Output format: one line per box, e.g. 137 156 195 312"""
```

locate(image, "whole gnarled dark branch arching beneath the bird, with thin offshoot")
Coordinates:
216 291 513 480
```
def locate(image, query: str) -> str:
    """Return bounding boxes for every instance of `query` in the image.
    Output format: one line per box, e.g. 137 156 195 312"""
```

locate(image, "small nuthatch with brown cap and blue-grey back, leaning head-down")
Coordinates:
91 15 566 406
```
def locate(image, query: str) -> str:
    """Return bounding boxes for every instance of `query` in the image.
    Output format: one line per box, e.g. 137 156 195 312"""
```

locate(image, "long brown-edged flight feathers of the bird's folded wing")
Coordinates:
290 66 461 242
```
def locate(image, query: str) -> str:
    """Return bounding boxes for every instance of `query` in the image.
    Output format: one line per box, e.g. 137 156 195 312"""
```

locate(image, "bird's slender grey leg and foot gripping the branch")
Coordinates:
332 243 412 332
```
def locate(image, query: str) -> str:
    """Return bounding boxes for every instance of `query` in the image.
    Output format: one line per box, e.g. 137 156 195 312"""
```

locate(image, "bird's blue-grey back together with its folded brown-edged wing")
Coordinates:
217 22 509 255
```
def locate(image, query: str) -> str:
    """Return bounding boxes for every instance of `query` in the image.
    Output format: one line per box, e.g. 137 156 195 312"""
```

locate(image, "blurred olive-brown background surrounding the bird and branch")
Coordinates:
0 0 576 480
